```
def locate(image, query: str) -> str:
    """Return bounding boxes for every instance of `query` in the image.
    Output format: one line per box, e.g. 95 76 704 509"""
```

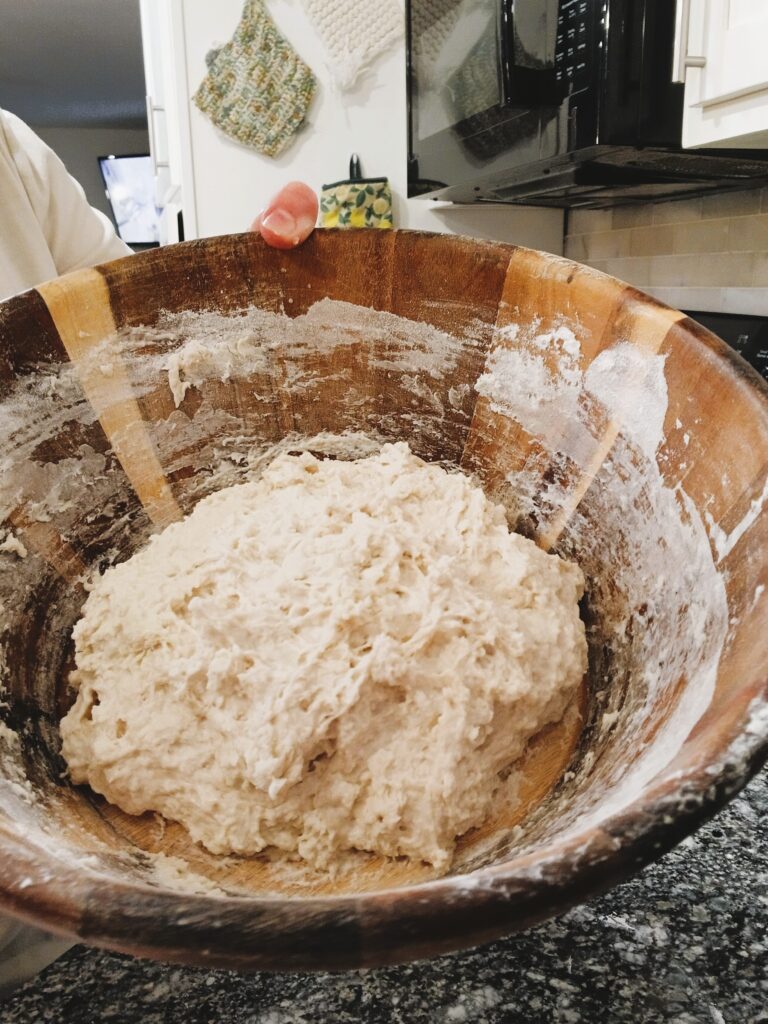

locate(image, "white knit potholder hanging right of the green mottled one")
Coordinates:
303 0 404 89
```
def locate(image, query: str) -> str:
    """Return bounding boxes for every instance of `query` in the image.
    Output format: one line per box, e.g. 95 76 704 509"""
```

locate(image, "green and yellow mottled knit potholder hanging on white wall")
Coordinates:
194 0 315 157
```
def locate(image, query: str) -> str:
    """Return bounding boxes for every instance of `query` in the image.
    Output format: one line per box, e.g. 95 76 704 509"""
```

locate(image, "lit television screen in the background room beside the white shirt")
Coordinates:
98 155 160 245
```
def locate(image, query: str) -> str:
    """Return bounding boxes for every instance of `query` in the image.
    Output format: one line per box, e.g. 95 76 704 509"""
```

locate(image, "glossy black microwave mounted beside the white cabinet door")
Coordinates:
407 0 768 208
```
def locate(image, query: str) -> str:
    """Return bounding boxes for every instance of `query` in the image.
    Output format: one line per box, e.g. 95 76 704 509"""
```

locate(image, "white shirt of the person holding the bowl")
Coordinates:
0 110 131 300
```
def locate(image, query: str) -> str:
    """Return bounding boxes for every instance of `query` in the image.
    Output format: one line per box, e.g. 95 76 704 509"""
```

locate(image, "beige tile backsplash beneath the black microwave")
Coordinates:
565 188 768 315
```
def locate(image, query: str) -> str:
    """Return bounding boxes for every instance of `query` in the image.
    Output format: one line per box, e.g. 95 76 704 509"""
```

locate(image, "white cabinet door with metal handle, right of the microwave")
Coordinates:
678 0 768 150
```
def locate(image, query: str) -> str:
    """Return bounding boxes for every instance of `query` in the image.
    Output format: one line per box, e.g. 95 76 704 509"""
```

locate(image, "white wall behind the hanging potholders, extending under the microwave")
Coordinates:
183 0 563 253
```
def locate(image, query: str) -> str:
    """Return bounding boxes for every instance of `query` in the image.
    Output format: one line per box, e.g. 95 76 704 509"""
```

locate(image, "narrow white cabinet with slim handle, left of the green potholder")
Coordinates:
140 0 197 245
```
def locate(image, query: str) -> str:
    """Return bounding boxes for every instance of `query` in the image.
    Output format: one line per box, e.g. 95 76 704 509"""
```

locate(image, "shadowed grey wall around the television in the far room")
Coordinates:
35 127 150 225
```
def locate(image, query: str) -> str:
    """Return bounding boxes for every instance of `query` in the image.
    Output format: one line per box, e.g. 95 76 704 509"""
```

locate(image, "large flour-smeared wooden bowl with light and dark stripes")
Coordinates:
0 231 768 970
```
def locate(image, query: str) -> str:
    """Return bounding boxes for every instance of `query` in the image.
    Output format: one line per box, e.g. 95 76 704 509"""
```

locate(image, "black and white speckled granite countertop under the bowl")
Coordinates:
0 770 768 1024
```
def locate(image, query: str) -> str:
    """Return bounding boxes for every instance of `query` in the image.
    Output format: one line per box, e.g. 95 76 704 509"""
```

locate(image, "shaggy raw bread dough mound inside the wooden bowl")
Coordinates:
61 443 587 868
